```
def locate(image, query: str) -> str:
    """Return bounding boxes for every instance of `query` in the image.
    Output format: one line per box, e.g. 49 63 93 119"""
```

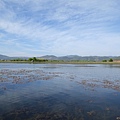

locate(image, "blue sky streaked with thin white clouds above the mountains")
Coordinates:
0 0 120 57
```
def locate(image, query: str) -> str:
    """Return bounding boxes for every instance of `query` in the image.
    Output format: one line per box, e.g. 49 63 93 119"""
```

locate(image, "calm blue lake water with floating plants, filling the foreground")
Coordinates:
0 63 120 120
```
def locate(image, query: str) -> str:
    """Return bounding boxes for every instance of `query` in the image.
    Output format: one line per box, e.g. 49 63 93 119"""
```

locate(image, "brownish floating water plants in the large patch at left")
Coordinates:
0 69 63 84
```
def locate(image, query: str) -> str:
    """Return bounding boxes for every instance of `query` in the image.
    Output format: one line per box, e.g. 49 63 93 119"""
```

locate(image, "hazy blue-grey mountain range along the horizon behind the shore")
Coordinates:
0 55 120 61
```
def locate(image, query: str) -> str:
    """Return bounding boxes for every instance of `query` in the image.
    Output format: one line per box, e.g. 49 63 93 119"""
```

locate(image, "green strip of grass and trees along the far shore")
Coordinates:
0 57 120 64
